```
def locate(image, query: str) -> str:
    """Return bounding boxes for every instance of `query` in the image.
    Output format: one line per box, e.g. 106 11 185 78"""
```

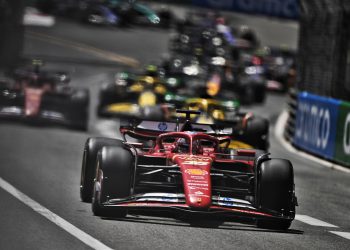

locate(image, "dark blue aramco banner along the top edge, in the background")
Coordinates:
192 0 299 19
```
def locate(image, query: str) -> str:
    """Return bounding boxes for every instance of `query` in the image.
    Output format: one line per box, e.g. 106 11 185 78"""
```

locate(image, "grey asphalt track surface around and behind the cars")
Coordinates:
0 10 350 249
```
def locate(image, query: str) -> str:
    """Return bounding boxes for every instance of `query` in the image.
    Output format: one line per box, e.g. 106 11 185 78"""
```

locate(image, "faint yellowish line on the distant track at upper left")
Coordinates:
26 31 140 67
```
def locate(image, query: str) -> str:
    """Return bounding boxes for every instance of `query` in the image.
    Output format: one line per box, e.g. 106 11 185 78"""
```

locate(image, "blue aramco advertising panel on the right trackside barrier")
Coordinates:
293 92 341 160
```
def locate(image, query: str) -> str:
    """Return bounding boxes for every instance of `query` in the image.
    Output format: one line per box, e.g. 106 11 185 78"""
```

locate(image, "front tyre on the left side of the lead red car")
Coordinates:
92 146 134 217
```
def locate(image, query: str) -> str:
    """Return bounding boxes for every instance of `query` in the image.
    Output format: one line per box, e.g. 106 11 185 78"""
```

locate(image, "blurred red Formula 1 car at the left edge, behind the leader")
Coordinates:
0 64 89 130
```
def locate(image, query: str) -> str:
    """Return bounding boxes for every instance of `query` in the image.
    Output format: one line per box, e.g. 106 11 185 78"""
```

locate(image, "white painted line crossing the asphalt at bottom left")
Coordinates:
0 177 112 250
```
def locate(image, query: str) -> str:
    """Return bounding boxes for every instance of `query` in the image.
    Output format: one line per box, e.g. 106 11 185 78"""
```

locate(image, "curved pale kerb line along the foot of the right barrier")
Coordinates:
275 110 350 173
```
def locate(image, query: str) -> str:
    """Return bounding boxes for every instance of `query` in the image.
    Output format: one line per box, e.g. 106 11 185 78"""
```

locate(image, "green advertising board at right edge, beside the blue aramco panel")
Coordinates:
334 99 350 166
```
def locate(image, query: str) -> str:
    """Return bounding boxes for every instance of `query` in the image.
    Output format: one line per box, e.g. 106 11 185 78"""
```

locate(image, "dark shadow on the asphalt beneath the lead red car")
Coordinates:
102 214 304 235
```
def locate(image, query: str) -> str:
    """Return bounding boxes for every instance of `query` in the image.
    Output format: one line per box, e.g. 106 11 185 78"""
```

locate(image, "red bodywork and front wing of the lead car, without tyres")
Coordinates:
105 127 281 221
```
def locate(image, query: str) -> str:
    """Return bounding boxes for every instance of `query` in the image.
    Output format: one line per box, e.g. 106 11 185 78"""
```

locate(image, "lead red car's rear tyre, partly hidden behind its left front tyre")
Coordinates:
80 137 123 202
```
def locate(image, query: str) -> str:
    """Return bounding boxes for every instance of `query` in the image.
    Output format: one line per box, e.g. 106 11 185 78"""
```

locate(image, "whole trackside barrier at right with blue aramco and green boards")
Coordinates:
284 90 350 167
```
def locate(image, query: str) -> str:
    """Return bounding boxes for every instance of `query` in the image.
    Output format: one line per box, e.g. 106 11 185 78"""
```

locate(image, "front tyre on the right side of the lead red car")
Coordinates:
255 159 295 230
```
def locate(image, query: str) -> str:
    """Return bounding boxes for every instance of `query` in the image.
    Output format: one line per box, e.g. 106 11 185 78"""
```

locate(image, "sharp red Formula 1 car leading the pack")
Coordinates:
80 111 297 229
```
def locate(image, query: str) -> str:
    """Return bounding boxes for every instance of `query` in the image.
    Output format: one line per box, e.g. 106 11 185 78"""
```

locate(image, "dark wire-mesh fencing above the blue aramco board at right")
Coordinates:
296 0 350 101
